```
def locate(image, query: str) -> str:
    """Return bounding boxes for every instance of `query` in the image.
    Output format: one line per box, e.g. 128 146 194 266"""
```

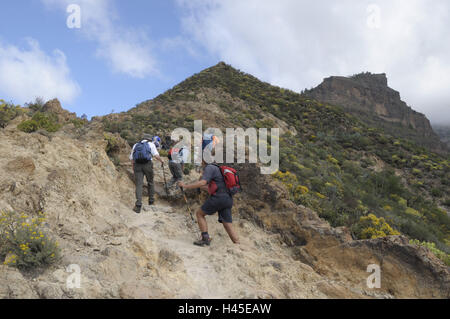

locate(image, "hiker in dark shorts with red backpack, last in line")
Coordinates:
178 135 241 246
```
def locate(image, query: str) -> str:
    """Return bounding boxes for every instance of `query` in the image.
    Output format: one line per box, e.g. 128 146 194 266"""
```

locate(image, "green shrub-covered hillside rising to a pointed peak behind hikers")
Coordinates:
101 63 450 254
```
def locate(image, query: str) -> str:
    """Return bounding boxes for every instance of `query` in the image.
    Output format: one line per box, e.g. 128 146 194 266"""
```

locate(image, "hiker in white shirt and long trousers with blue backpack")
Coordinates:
130 134 164 214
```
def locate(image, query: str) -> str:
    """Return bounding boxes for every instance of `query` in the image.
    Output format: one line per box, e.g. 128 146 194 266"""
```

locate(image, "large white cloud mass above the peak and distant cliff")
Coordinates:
177 0 450 122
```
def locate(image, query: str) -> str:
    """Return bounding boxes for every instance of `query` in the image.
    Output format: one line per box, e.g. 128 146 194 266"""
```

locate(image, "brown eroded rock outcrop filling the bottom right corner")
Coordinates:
307 236 450 298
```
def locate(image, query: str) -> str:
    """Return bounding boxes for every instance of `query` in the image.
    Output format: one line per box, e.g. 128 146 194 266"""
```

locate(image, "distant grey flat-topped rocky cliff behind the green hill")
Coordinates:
305 73 447 152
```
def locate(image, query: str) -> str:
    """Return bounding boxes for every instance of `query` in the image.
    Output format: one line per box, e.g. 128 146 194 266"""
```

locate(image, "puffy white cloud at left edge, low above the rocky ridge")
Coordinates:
0 39 81 103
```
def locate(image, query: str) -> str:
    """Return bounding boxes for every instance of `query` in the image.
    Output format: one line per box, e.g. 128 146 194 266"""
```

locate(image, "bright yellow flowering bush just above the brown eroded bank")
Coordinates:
353 214 400 239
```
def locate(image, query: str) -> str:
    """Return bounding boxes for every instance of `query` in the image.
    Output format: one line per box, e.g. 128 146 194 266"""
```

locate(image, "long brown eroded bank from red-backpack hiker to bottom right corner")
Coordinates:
230 166 450 298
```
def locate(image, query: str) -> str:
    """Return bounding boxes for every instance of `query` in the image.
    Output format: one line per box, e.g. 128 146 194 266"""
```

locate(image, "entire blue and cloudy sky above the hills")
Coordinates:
0 0 450 123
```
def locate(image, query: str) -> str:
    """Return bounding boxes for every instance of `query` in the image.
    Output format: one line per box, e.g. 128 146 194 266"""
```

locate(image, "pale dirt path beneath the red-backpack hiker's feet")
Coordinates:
123 204 325 298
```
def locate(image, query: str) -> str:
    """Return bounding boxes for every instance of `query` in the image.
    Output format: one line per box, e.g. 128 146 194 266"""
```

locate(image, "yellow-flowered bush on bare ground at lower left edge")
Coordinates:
0 212 60 270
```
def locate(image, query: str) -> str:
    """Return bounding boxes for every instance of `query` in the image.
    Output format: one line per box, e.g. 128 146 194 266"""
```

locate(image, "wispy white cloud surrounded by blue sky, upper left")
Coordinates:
42 0 157 78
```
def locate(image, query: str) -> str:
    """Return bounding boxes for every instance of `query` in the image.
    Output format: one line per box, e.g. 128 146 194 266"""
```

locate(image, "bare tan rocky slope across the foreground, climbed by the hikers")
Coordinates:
0 111 450 298
